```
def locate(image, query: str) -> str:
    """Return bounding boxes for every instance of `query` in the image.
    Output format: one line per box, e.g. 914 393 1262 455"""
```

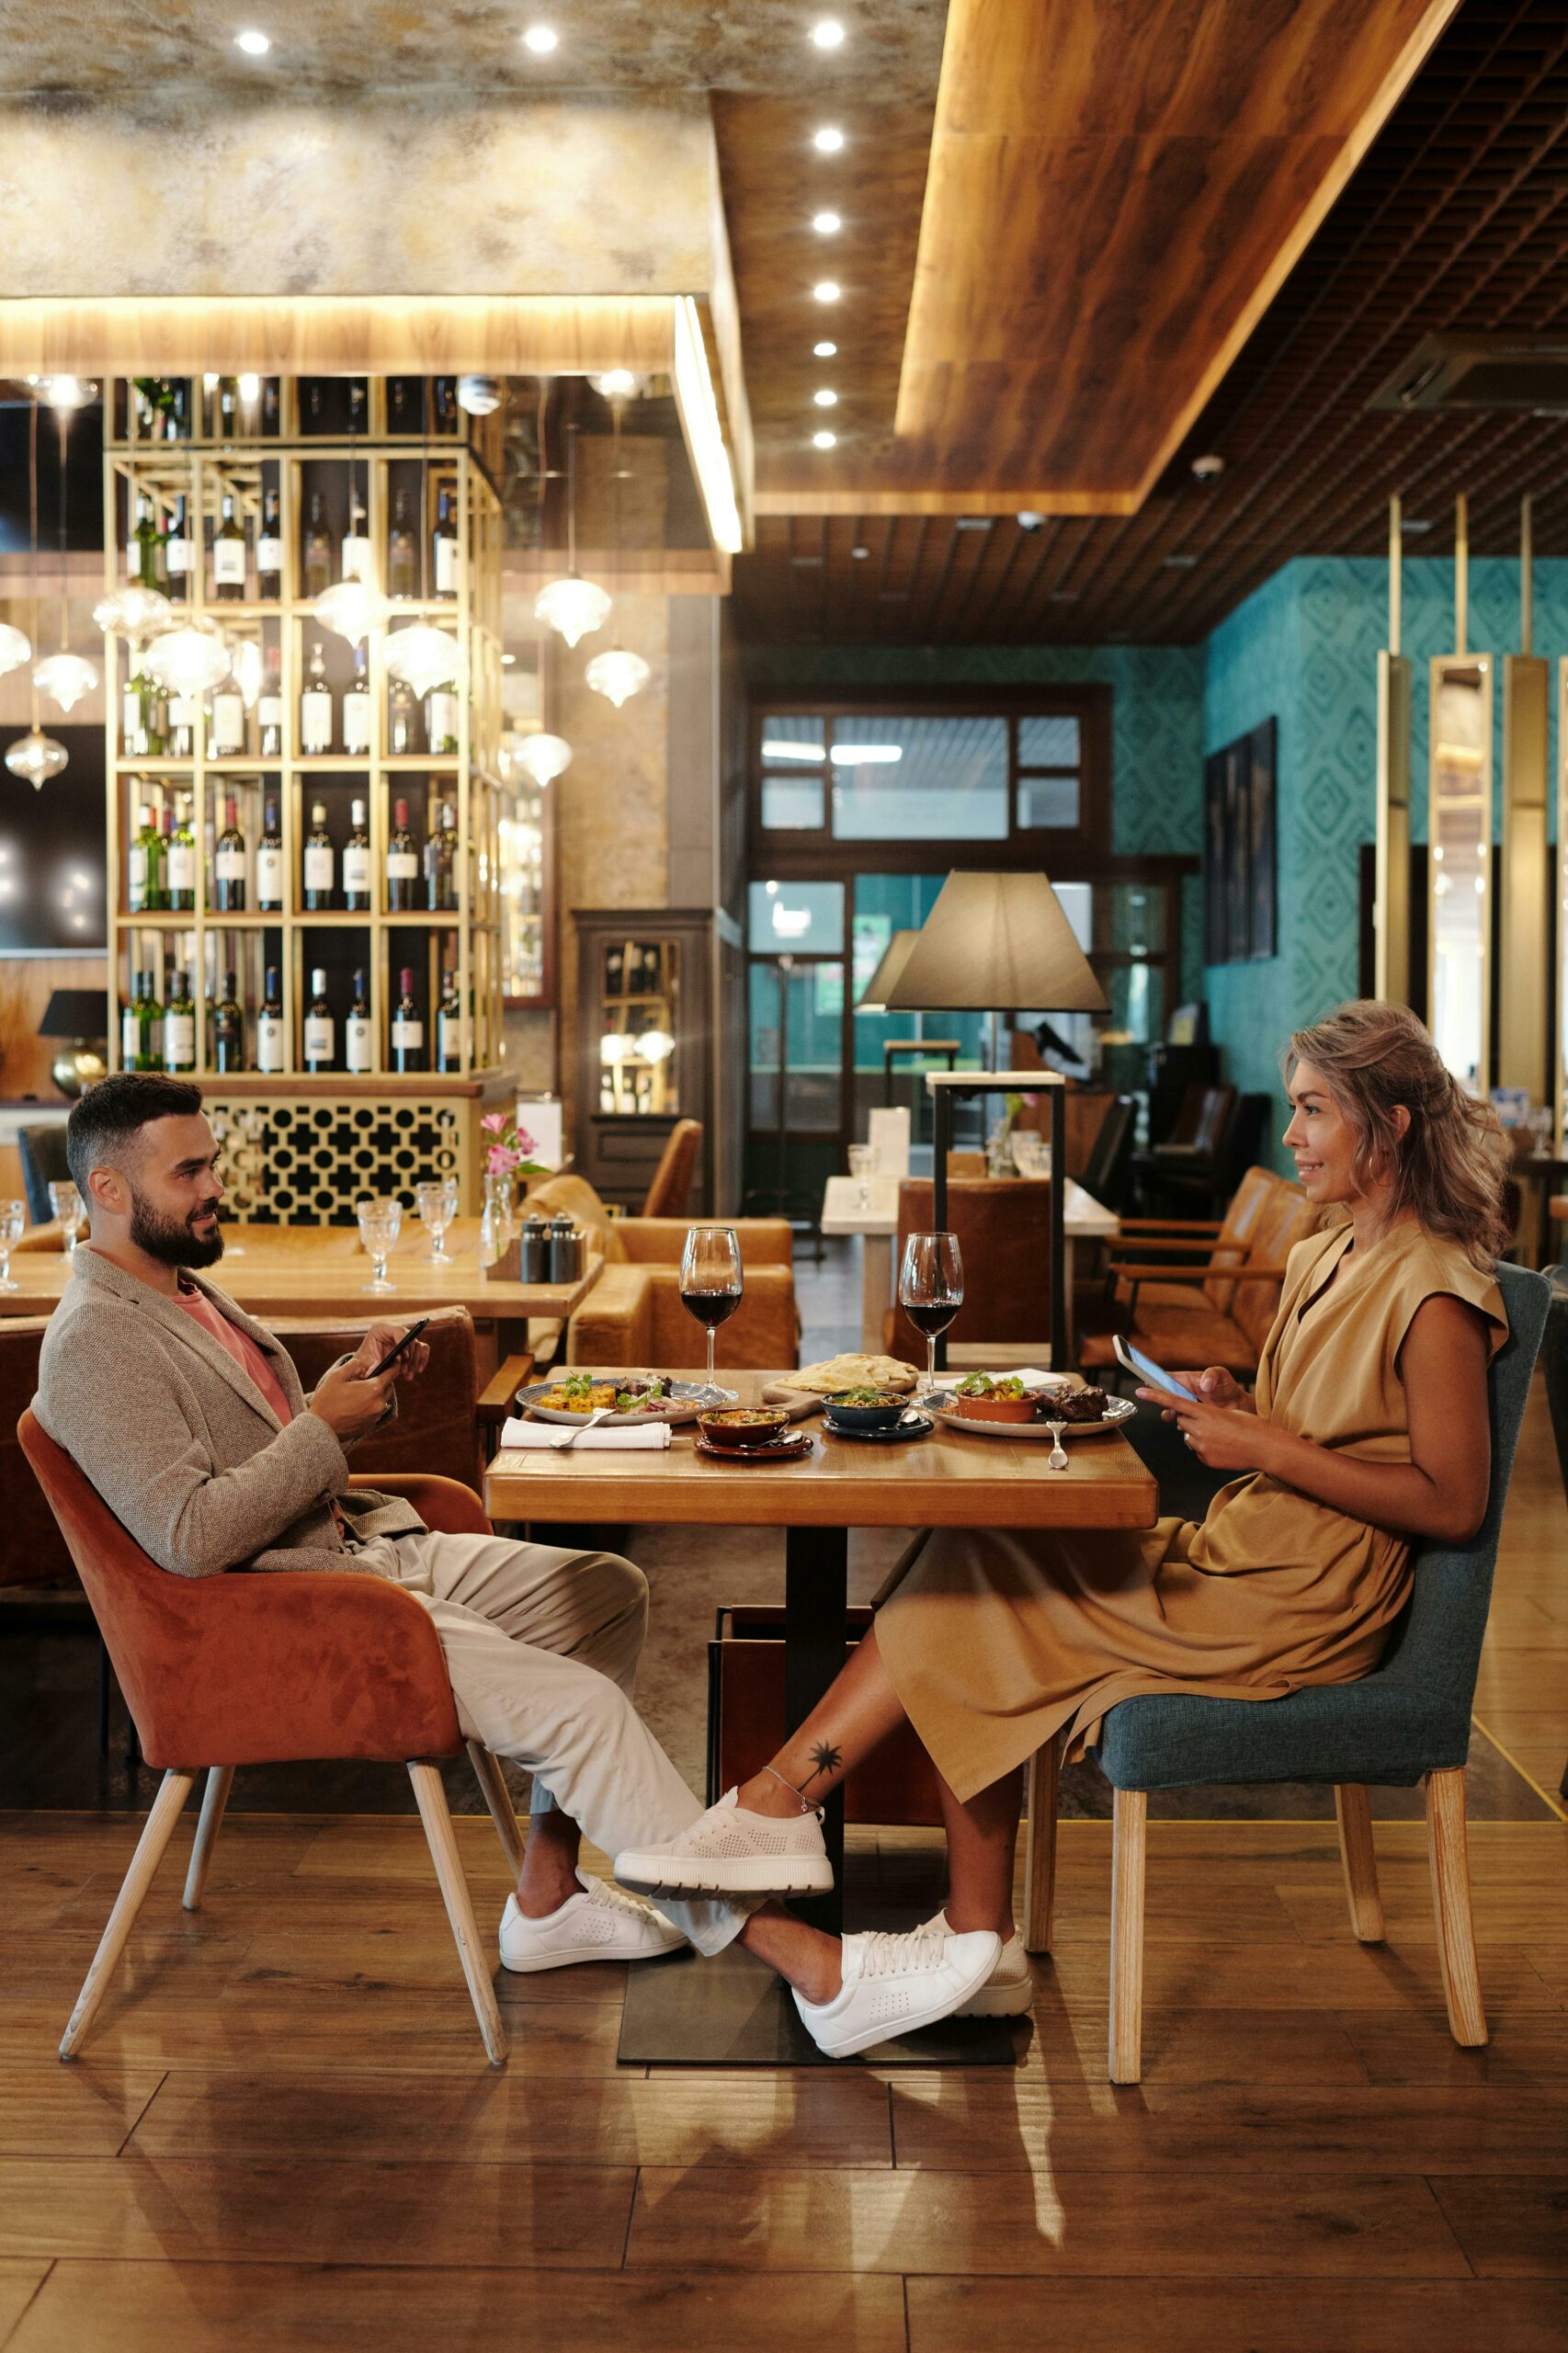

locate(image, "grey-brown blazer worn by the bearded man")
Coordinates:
33 1243 424 1576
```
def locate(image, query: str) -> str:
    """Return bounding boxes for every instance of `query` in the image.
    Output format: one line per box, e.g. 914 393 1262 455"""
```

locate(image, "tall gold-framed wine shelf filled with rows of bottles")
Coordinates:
104 379 513 1097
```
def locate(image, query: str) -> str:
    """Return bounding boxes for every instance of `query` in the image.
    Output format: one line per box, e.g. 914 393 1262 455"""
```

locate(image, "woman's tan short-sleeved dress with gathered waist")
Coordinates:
876 1222 1506 1798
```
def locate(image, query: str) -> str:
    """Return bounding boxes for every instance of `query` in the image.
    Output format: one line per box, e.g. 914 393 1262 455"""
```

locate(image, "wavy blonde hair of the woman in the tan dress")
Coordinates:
1280 997 1512 1273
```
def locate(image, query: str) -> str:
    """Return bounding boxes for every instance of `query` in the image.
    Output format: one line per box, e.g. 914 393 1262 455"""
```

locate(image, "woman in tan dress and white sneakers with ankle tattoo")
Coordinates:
617 1000 1506 2050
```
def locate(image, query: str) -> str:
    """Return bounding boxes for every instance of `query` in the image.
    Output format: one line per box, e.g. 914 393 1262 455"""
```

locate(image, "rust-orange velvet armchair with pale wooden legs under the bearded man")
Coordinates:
17 1407 523 2066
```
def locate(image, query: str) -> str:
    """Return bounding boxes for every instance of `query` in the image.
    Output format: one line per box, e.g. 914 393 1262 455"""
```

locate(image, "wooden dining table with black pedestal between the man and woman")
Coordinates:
485 1371 1158 2063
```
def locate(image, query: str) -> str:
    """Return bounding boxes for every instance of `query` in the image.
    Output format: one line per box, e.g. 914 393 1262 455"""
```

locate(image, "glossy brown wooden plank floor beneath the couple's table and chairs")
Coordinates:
0 1398 1568 2353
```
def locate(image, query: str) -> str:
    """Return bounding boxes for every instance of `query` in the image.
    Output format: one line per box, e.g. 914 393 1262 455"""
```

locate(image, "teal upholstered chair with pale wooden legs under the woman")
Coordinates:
1024 1266 1550 2083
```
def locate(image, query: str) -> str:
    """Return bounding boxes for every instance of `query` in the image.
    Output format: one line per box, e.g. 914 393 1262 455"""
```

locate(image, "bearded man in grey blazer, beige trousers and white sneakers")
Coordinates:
33 1073 1001 2056
